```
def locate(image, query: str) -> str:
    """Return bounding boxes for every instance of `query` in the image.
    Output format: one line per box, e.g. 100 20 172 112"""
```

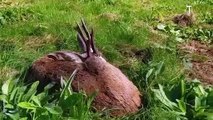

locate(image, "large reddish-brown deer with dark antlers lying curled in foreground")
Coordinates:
27 21 141 116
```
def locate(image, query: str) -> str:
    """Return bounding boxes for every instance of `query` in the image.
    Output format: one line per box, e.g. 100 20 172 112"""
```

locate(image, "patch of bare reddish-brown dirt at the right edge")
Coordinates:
180 40 213 85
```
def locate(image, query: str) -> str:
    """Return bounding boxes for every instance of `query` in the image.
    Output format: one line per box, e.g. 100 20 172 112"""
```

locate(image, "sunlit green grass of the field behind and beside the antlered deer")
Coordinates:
0 0 213 120
